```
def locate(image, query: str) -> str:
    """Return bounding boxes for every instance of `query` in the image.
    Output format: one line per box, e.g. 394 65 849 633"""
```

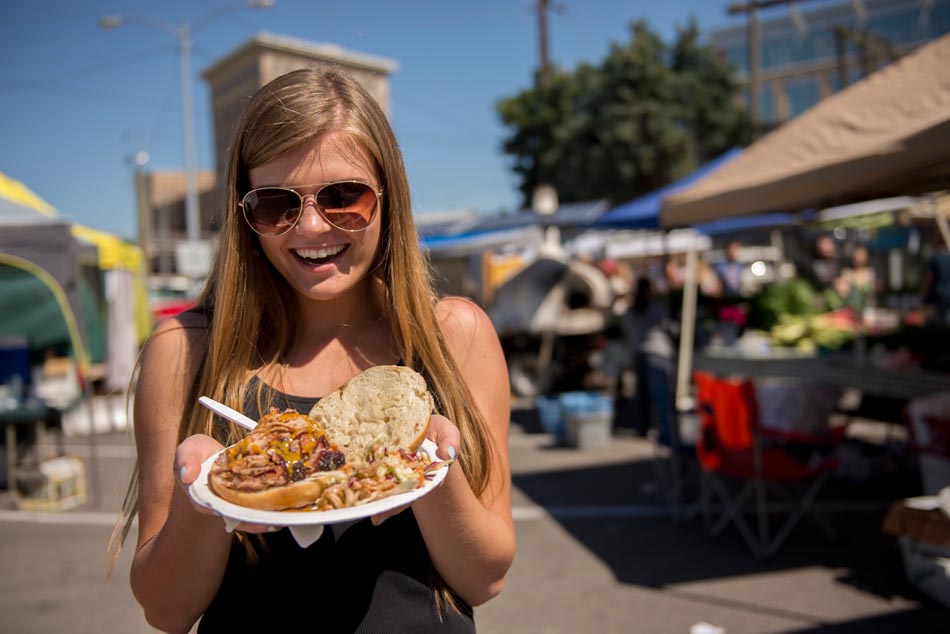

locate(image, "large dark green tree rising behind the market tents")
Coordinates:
497 21 749 206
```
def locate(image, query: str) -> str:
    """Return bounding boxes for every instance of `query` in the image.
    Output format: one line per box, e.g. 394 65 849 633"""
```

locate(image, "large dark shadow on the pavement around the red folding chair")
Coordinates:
513 404 948 634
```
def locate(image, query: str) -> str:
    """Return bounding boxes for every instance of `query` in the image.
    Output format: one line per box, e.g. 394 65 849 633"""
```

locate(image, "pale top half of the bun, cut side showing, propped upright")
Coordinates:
310 365 434 463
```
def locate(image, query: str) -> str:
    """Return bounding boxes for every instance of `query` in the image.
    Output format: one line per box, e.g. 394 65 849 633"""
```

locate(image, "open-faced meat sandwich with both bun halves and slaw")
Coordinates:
209 366 434 511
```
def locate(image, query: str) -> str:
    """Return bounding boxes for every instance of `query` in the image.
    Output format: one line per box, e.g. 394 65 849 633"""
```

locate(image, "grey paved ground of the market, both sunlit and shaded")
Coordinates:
0 402 950 634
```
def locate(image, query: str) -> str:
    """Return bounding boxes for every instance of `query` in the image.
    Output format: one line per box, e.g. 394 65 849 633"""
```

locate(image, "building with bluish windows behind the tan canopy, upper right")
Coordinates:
708 0 950 129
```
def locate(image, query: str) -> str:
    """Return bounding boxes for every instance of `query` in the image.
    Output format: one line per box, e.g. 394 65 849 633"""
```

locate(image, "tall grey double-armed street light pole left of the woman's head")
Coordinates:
99 0 275 241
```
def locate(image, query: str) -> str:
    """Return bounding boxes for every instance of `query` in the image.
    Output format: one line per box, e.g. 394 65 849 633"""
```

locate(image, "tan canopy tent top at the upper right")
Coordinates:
660 35 950 227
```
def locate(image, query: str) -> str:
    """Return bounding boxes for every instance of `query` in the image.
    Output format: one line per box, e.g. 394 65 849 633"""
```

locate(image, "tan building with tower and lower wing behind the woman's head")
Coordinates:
136 33 399 277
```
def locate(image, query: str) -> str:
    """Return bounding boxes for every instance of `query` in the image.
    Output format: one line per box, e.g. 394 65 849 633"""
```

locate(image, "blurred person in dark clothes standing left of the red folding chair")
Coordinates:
621 277 676 442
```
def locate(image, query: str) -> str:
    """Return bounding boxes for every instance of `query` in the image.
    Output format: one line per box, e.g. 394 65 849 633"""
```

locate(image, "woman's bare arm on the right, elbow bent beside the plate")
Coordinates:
412 298 515 606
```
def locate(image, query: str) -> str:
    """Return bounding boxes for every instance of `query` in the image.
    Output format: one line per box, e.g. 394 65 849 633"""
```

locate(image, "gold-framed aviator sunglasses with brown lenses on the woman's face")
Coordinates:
238 181 383 237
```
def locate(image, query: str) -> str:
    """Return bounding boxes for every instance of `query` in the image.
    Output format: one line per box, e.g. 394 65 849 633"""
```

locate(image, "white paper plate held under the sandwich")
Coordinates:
188 438 448 527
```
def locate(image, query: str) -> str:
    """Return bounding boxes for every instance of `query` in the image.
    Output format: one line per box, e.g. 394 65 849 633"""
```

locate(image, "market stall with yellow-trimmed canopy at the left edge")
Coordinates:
0 174 151 504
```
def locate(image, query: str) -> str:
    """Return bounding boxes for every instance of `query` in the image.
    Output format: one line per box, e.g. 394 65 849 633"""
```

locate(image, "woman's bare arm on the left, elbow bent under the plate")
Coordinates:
130 315 231 632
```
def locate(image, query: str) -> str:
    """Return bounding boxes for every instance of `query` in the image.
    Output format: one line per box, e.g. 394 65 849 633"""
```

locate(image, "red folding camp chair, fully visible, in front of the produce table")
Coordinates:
693 372 844 558
